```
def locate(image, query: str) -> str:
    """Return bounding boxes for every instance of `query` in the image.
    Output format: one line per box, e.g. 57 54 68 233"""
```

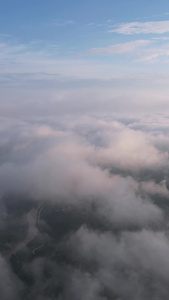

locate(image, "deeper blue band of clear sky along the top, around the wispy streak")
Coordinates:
0 0 169 53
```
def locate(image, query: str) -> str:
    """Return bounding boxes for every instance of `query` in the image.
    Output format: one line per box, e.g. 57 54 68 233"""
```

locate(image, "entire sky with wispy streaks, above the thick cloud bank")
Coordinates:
0 0 169 115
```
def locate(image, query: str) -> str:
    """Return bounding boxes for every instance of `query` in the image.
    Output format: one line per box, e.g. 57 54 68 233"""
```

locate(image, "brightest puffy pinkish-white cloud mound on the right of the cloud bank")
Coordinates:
89 124 168 171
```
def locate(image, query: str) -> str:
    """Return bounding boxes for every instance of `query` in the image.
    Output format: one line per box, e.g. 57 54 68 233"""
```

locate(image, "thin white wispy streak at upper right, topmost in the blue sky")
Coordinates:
110 21 169 35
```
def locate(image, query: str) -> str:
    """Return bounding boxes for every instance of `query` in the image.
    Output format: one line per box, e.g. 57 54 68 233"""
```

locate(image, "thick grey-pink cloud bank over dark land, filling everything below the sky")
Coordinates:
0 116 169 300
